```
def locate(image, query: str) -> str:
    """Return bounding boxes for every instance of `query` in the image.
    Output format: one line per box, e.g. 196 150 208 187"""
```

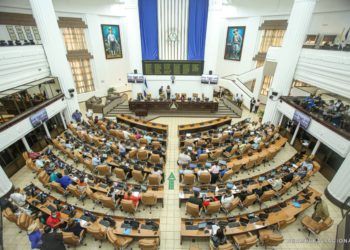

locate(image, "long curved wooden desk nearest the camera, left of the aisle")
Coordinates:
27 186 160 238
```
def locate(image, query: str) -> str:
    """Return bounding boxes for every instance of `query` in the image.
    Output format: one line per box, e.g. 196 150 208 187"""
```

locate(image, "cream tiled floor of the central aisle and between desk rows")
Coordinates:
3 108 341 250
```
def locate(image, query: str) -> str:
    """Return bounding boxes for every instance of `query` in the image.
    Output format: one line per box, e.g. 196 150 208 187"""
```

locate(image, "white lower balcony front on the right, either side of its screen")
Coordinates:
277 99 350 157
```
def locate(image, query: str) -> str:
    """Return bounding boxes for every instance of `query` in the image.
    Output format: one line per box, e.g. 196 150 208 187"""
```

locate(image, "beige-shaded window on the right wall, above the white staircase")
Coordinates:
253 20 288 68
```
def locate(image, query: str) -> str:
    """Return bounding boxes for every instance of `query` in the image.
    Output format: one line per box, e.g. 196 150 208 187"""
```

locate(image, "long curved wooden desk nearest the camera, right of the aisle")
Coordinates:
180 188 321 244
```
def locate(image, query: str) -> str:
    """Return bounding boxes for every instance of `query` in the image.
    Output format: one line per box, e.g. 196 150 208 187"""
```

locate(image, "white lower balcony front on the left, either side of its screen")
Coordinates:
0 99 67 151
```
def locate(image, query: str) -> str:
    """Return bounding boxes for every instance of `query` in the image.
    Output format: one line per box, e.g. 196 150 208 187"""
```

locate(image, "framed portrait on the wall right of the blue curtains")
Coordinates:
224 26 245 61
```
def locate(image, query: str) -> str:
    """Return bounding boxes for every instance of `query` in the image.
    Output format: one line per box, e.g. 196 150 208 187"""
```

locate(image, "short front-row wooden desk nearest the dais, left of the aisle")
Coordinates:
116 114 168 134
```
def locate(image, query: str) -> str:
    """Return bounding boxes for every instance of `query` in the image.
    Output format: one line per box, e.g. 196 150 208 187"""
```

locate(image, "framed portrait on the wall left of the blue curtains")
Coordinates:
101 24 123 59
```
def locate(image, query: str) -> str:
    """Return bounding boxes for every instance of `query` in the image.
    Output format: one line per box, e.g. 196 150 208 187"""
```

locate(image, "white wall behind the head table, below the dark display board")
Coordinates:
132 76 215 100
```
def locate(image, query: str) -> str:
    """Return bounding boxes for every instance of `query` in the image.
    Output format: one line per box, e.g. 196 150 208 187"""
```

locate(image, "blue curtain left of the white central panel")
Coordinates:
139 0 159 60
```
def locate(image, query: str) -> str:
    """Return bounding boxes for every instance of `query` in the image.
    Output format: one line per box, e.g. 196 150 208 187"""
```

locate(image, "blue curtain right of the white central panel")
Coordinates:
187 0 209 61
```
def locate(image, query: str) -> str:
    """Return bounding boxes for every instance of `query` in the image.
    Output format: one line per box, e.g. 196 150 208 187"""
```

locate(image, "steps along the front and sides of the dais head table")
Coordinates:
106 100 239 121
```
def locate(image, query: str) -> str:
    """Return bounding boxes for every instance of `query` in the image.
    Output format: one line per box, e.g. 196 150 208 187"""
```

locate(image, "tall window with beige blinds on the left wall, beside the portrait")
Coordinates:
58 17 95 94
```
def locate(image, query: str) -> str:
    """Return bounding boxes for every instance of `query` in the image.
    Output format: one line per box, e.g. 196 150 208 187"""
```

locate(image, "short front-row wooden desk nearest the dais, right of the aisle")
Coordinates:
178 116 232 135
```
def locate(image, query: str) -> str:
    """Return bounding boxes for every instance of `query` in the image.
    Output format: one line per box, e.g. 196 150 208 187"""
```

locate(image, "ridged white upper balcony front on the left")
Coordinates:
0 45 50 91
